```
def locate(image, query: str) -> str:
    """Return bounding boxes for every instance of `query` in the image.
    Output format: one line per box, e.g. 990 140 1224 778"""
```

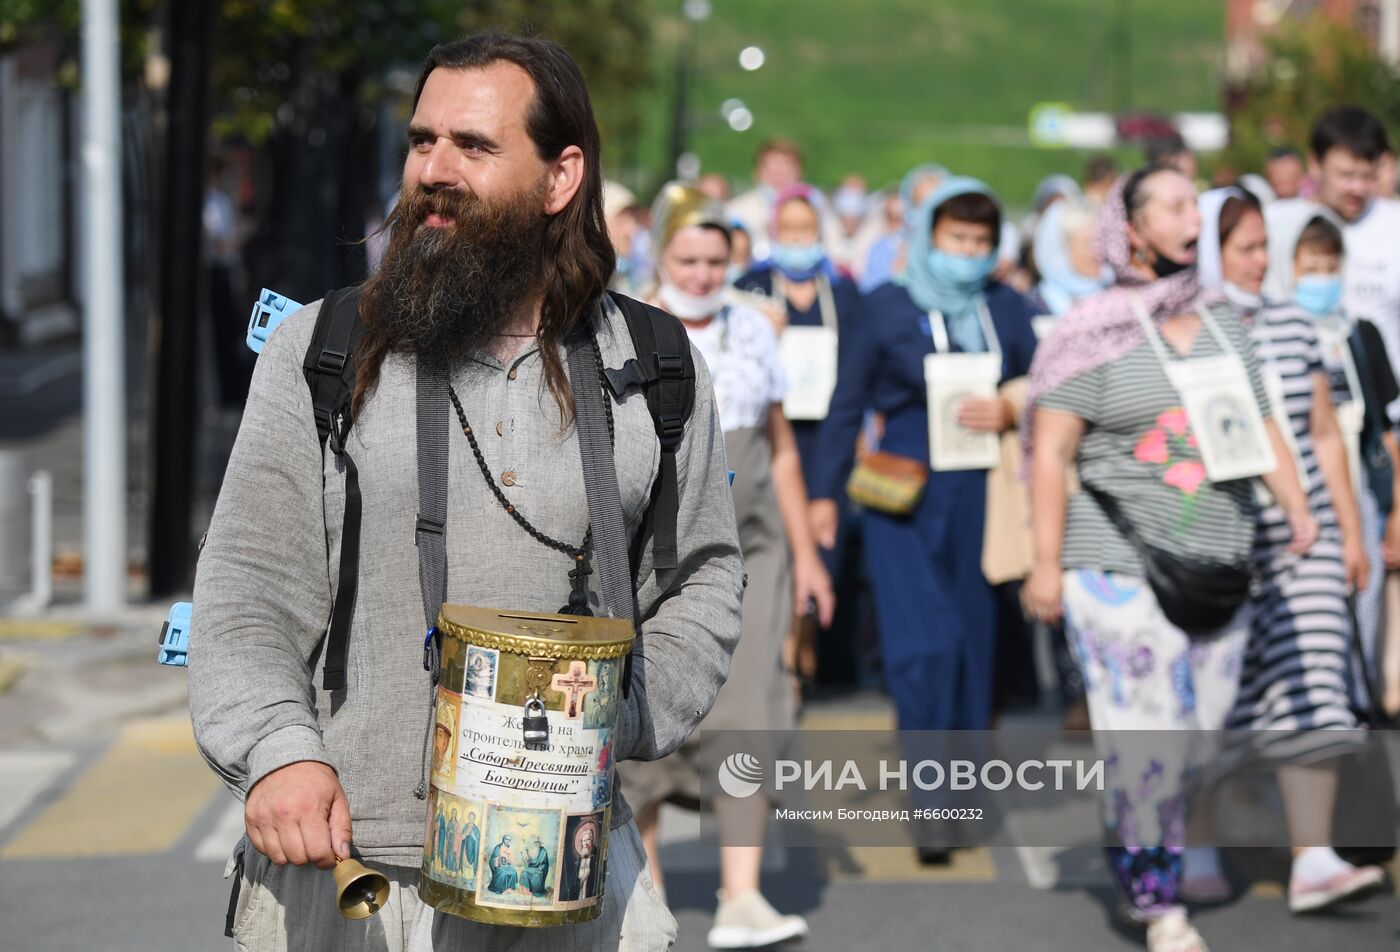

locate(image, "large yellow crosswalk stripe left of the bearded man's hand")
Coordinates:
0 718 218 860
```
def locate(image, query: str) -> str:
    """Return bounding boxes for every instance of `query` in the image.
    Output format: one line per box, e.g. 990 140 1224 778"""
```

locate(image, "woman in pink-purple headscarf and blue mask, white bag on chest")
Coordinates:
736 185 861 680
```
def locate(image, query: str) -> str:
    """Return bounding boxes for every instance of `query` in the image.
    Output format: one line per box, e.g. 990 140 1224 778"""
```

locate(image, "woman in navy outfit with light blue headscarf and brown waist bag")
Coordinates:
811 178 1036 861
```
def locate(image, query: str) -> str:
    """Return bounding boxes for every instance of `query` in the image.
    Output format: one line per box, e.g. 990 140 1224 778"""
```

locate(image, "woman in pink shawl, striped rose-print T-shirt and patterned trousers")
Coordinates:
1025 165 1317 952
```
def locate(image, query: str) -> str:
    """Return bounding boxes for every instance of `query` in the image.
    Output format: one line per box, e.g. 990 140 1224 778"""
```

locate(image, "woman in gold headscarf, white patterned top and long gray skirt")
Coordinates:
619 182 833 949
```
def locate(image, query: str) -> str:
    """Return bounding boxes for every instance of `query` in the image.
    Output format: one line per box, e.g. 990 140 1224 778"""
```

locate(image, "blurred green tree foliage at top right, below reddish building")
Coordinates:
1229 13 1400 168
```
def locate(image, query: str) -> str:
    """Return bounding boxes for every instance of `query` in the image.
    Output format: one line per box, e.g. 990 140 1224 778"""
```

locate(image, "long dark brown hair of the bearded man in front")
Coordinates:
351 32 617 421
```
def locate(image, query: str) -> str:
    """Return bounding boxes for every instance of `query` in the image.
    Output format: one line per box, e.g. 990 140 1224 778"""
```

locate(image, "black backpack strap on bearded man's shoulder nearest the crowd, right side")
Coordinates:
605 291 696 571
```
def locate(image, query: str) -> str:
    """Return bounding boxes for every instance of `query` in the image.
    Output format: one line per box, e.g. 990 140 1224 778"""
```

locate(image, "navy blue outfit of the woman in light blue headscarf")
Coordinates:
809 283 1037 731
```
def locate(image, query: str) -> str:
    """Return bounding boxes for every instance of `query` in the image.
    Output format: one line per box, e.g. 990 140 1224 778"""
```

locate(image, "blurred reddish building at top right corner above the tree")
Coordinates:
1225 0 1400 85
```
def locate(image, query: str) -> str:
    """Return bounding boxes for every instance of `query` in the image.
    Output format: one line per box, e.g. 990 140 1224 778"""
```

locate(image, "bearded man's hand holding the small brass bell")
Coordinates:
244 760 350 869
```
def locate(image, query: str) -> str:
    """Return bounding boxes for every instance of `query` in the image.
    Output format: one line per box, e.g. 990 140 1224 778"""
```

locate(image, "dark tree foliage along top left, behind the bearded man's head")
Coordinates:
0 0 651 158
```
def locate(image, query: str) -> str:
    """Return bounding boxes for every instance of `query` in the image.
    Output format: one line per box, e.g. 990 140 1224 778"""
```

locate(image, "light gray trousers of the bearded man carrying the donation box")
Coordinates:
234 822 676 952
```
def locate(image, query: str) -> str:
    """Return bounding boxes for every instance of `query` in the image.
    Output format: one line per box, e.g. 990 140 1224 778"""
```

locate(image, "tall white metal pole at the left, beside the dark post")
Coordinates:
83 0 126 612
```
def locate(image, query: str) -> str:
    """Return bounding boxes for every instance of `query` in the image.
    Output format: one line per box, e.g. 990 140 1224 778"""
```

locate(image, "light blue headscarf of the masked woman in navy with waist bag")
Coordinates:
903 175 1001 354
